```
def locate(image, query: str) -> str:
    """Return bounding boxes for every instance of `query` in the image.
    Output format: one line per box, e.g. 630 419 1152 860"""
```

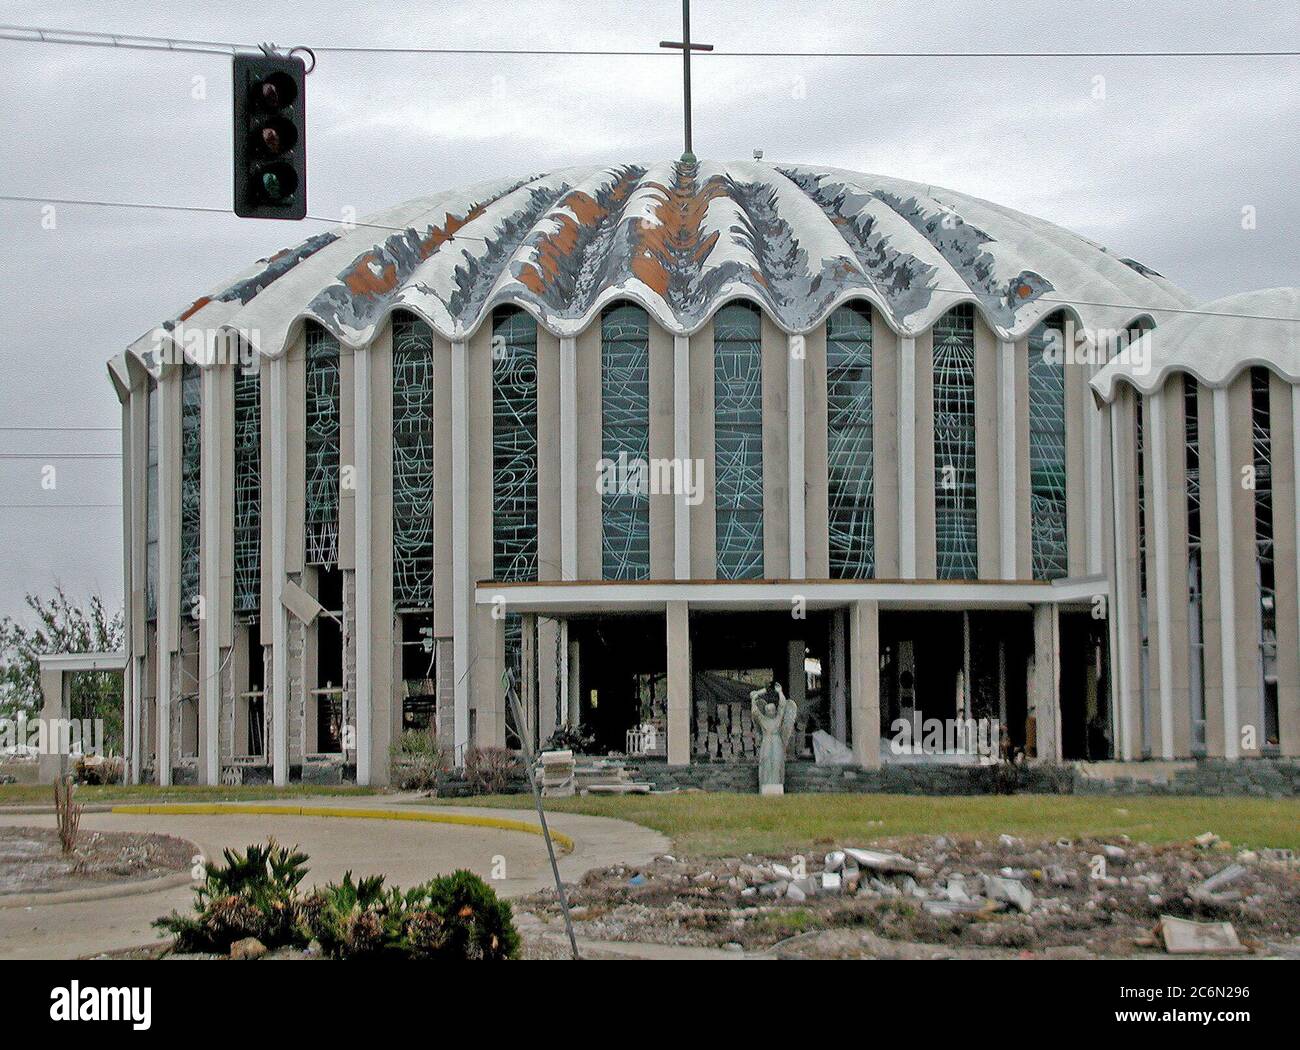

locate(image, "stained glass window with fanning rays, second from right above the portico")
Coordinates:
933 303 979 580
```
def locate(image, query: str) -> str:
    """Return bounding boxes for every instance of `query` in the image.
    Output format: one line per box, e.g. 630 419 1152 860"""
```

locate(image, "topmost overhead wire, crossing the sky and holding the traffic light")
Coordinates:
0 25 1300 58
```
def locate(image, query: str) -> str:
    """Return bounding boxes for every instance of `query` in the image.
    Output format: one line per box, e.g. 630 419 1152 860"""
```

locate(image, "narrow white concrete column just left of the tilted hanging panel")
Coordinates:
264 352 289 788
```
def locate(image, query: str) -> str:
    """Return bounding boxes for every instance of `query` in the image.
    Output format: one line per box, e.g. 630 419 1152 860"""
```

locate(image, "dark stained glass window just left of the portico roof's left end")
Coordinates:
393 313 433 609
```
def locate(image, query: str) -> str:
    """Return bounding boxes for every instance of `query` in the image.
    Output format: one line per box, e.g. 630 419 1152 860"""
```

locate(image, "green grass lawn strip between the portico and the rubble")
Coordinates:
436 793 1300 856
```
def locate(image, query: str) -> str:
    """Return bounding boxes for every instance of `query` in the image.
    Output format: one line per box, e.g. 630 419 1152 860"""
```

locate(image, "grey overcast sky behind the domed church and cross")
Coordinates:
0 0 1300 615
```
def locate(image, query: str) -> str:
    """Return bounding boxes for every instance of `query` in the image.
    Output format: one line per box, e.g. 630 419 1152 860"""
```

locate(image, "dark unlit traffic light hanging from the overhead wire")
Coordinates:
233 55 307 218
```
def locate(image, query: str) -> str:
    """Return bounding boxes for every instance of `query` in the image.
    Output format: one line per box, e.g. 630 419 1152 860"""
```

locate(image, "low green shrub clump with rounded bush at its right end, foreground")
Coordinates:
304 871 519 960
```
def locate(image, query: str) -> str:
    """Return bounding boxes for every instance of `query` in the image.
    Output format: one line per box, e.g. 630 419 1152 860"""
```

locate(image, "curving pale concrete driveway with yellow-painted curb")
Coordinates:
0 795 668 959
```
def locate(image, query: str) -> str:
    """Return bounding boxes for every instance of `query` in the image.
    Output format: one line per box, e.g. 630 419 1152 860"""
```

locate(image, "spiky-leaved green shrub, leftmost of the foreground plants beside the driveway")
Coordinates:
153 839 308 954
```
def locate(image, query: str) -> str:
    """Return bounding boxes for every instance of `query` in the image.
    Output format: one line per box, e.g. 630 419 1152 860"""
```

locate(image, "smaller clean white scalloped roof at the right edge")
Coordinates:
1092 288 1300 402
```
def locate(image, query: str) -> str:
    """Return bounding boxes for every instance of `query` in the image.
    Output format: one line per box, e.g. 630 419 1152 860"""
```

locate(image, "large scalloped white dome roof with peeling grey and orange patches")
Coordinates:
133 161 1190 366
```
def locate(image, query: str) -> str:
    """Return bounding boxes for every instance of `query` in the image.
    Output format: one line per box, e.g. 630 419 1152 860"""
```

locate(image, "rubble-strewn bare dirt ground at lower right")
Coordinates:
520 836 1300 958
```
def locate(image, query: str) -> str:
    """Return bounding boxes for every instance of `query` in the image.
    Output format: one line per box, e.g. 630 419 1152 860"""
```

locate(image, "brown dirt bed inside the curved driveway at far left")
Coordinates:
0 826 195 894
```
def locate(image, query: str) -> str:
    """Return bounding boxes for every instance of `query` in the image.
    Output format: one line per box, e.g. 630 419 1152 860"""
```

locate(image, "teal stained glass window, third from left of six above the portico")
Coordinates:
714 303 763 580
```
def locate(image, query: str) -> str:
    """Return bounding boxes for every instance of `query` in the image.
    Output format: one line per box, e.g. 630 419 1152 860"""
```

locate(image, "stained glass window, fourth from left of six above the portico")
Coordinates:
826 303 875 580
